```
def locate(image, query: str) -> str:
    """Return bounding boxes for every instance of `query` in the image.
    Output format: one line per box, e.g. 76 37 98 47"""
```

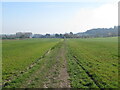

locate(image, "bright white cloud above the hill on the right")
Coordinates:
65 3 118 32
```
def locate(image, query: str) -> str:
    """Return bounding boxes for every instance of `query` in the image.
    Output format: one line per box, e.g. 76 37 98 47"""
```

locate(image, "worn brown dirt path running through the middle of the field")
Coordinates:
44 40 70 88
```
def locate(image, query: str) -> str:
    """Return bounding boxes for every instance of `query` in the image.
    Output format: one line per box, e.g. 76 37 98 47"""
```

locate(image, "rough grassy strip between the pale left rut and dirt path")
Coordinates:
2 41 62 88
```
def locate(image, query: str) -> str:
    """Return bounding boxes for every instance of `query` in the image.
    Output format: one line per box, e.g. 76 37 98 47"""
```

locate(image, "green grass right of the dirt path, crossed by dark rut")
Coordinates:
67 37 118 88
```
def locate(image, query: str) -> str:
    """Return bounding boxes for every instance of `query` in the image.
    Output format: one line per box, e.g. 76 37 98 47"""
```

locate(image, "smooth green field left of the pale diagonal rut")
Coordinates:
2 39 60 81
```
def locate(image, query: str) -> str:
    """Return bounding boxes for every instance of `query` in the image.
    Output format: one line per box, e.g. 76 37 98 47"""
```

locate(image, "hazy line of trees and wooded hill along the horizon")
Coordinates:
0 26 120 39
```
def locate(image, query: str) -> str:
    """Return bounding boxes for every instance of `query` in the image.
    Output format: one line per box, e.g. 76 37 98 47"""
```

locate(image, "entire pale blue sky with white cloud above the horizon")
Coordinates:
0 0 118 34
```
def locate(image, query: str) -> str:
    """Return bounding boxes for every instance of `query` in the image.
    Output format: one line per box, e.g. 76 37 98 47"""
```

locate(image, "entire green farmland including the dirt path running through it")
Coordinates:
2 37 118 88
